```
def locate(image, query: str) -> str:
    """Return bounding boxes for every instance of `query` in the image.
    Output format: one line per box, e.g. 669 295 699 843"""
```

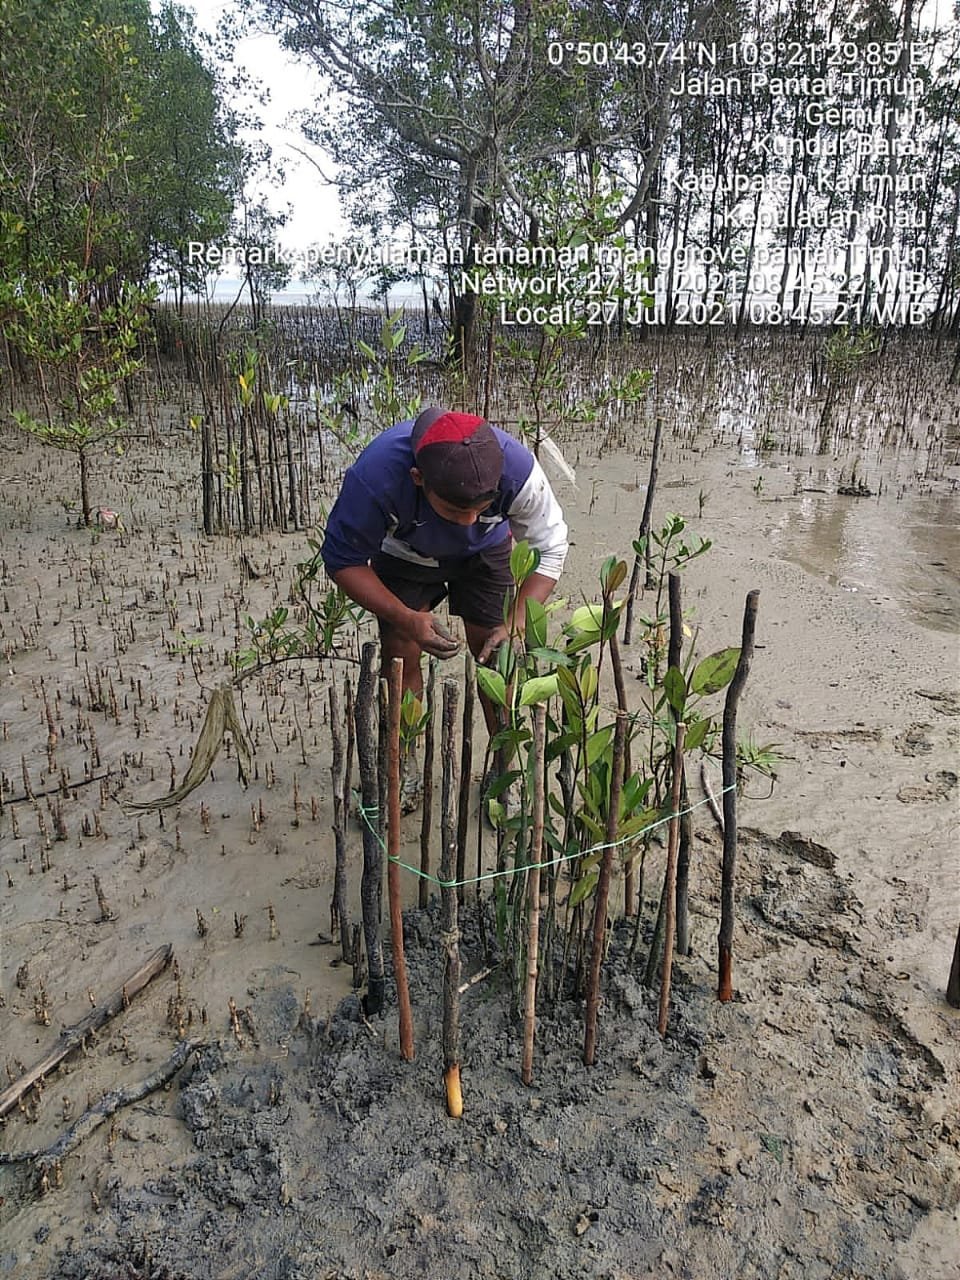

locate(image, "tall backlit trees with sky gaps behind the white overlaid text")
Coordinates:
251 0 960 347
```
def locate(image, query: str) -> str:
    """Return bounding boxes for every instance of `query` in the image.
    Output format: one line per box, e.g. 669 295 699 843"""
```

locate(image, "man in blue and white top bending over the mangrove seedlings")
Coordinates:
321 407 567 795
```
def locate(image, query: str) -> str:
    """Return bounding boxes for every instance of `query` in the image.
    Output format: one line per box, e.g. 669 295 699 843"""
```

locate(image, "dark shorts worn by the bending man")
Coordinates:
370 538 513 628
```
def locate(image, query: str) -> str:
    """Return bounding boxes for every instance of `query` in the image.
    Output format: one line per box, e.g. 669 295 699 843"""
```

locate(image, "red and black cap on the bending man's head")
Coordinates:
410 406 503 507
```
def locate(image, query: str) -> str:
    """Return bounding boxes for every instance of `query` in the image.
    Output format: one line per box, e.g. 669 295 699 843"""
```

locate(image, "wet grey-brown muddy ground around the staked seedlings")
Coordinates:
0 332 960 1280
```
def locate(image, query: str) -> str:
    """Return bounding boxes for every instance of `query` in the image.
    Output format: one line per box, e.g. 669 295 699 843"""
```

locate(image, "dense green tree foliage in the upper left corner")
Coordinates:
0 0 243 307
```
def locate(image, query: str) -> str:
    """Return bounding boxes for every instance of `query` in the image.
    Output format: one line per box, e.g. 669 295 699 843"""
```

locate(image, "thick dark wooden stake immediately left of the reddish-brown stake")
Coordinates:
353 640 384 1018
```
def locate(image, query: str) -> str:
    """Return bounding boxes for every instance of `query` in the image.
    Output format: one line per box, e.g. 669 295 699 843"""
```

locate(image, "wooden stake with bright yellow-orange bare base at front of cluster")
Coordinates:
440 680 463 1120
